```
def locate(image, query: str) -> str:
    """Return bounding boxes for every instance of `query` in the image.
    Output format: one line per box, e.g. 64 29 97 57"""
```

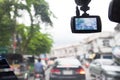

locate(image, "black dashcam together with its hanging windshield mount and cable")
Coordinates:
71 0 101 33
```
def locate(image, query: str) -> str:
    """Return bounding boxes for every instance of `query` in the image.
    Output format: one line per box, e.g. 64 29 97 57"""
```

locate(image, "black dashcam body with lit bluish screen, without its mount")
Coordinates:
71 16 101 33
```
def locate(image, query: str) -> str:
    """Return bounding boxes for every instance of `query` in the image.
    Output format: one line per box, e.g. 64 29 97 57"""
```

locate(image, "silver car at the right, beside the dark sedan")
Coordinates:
89 59 120 80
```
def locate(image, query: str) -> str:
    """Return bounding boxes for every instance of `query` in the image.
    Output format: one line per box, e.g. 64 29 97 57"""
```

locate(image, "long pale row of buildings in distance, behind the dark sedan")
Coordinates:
49 42 85 57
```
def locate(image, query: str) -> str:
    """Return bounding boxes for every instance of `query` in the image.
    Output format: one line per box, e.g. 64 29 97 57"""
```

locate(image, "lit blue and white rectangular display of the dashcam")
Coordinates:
75 18 97 30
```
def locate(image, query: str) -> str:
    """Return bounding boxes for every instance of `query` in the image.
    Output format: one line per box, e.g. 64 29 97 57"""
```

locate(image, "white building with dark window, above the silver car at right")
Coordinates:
85 32 115 58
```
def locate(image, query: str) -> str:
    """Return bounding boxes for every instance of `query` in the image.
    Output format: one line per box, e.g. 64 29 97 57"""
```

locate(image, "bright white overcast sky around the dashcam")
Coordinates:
46 0 116 46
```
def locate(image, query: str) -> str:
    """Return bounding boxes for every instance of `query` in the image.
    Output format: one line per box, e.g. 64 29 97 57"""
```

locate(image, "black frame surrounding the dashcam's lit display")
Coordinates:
71 16 101 33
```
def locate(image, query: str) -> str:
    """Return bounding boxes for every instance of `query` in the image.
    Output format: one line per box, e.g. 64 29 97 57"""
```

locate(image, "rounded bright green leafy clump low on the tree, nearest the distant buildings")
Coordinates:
28 32 53 54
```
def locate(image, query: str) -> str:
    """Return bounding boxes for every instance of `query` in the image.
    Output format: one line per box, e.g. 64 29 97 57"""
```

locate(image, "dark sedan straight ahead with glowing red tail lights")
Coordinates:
50 58 85 80
